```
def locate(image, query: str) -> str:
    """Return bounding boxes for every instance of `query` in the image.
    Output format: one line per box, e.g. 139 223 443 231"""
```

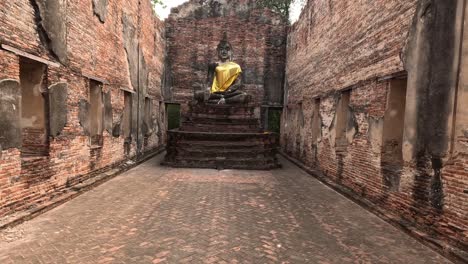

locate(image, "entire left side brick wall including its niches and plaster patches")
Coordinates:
0 0 165 216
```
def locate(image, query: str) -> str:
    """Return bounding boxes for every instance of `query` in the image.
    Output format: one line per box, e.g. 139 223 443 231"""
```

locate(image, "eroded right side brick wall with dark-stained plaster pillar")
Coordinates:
281 0 468 254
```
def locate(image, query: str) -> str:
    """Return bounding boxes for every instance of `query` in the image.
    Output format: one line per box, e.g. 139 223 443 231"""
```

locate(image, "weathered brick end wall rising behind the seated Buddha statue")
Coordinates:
166 0 287 110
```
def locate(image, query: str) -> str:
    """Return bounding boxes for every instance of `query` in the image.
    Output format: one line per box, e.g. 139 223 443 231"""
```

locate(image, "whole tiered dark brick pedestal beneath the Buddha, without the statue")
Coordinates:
163 104 279 170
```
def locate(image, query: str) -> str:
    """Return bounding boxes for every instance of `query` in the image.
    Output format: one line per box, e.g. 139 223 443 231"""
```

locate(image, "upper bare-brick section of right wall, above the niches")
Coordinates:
287 0 417 101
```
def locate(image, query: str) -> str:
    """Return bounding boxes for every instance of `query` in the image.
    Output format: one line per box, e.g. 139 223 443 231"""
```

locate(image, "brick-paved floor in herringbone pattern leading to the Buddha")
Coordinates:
0 157 450 264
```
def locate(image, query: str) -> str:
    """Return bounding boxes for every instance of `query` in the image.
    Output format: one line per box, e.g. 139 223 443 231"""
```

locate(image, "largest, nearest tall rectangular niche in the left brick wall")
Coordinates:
20 57 49 156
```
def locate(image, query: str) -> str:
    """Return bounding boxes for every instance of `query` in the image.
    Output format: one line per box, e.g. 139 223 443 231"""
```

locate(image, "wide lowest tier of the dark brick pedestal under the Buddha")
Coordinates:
163 126 279 170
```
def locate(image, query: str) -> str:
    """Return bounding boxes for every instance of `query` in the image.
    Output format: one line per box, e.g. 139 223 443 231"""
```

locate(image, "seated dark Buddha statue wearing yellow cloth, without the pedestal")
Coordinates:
195 33 249 104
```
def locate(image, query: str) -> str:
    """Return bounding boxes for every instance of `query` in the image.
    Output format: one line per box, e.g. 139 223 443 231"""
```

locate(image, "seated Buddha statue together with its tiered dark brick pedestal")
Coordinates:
163 34 279 170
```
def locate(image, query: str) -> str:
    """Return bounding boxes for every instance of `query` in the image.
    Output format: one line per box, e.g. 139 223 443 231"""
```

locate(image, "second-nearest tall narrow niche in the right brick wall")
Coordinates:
335 90 351 151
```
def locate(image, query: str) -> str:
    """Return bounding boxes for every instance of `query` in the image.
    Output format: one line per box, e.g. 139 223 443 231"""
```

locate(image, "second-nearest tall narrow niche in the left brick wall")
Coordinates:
89 80 104 147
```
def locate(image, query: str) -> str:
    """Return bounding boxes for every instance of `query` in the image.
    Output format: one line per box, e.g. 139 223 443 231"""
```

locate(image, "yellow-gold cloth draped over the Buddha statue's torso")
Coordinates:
211 62 242 93
